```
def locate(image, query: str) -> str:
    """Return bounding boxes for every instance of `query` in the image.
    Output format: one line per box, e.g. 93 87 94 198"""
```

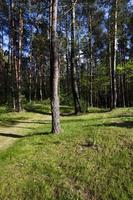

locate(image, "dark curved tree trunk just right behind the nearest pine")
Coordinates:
71 0 81 114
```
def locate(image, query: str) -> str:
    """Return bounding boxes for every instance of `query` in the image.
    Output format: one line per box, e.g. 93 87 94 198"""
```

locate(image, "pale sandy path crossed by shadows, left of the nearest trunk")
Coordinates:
0 114 50 151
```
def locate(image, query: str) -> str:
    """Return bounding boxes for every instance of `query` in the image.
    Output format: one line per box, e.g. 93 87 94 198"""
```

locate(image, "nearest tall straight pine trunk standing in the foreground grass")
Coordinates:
50 0 61 134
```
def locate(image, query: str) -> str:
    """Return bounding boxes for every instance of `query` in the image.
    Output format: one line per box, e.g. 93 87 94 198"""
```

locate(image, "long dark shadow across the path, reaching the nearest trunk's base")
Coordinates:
0 132 51 139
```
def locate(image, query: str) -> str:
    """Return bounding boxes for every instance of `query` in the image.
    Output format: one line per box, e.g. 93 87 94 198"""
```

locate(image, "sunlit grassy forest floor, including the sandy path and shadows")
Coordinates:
0 103 133 200
